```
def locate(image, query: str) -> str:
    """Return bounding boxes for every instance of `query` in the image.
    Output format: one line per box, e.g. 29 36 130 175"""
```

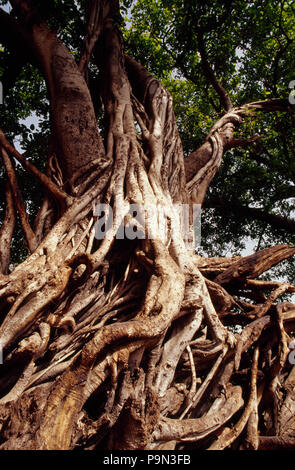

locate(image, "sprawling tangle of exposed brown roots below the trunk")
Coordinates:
0 183 295 449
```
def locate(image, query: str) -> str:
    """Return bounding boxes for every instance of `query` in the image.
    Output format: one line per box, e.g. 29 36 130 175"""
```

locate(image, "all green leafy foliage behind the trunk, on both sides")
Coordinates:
0 0 295 282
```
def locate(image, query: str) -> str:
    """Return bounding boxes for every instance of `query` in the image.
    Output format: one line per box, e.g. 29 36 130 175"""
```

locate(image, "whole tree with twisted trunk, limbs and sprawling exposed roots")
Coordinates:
0 0 295 450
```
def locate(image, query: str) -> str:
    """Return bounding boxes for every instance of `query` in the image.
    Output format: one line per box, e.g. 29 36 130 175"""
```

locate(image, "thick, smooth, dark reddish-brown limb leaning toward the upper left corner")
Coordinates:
11 0 105 177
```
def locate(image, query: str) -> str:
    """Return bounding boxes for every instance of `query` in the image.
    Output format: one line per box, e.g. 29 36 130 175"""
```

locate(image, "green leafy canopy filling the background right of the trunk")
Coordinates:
125 0 294 270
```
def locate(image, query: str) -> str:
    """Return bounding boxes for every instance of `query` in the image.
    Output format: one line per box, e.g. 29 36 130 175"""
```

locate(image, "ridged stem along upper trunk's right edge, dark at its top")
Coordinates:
125 55 187 202
